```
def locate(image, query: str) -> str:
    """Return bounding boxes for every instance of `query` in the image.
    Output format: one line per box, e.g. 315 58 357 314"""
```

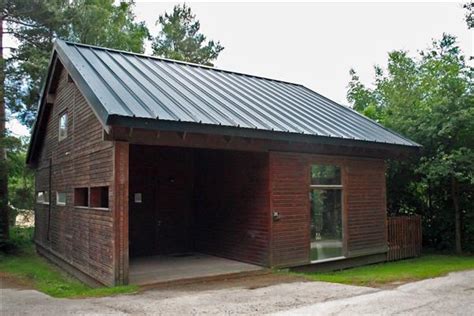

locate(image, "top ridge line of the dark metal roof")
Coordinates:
55 38 303 87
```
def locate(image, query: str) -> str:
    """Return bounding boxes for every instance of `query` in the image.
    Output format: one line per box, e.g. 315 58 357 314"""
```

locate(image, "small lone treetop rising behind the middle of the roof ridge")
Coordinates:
152 4 224 66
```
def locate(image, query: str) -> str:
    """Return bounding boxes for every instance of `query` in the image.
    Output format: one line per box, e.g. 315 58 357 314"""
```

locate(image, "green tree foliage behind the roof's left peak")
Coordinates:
2 0 149 126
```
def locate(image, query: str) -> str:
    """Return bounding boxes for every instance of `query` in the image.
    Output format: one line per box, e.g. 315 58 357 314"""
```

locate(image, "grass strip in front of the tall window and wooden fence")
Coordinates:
299 254 474 286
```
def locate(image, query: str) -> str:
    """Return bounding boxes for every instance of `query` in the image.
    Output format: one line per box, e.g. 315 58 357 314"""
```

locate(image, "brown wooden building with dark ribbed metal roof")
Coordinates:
27 41 419 285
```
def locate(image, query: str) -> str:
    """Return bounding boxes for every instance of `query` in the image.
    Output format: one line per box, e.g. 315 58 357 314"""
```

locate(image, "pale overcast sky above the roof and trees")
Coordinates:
5 0 474 134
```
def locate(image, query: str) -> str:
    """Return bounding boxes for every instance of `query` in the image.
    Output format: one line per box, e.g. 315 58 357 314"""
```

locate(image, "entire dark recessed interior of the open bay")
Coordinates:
129 145 270 265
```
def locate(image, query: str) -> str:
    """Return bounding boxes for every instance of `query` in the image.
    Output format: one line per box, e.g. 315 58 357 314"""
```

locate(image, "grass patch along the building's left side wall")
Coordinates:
0 227 138 298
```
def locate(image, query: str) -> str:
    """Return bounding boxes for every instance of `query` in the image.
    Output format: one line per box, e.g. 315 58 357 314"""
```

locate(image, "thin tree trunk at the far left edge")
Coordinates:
0 12 9 247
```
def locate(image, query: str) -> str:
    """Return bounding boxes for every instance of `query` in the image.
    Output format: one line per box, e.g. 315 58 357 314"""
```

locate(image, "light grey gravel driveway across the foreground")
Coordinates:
0 271 474 315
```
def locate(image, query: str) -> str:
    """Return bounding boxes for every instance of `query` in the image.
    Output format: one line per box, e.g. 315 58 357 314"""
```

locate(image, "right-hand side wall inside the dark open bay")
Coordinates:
194 150 271 266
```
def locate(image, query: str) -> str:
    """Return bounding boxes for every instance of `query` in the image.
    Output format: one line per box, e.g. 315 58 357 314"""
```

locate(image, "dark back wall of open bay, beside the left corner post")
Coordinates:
129 145 194 256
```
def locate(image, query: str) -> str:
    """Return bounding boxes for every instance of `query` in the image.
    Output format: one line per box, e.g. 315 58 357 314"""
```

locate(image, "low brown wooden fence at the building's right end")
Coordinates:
387 216 421 261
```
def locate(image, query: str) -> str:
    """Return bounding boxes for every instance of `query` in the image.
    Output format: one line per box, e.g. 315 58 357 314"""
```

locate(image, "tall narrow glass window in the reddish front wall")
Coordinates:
310 165 343 261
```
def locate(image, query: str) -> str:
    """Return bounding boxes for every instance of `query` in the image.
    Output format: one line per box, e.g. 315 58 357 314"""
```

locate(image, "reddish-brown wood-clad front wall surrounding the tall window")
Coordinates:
270 152 387 266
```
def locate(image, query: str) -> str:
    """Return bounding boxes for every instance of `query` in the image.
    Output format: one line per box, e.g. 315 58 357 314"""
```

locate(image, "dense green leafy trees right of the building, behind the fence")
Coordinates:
348 34 474 251
